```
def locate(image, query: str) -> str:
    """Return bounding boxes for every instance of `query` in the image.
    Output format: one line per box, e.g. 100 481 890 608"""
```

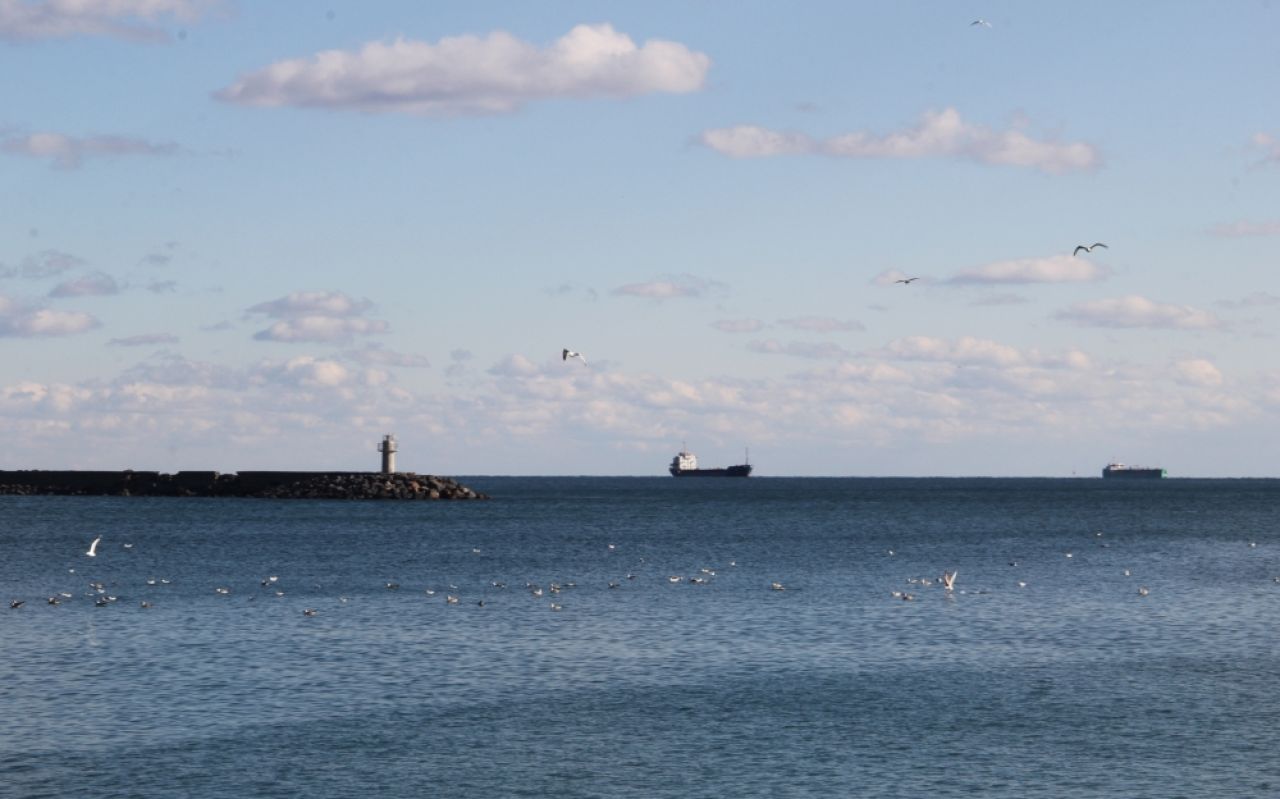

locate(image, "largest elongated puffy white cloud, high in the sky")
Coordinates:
216 24 710 115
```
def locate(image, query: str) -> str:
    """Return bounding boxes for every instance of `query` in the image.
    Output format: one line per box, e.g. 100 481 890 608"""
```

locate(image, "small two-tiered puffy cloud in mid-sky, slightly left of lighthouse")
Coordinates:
246 291 390 342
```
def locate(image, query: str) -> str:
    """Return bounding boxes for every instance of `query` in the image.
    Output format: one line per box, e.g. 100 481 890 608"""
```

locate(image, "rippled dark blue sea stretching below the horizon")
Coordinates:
0 478 1280 799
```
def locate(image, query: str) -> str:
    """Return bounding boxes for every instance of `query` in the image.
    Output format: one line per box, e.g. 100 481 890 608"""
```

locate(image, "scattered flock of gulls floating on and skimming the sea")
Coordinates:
9 524 1249 617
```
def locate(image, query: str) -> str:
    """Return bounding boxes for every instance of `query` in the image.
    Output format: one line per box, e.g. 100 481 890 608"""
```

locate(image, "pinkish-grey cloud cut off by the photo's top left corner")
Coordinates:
0 0 212 41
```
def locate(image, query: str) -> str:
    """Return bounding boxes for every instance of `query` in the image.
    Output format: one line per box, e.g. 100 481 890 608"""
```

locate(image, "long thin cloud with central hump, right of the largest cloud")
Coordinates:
699 108 1101 174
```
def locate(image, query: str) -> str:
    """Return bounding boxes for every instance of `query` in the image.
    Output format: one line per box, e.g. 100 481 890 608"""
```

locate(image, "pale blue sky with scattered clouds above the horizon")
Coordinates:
0 0 1280 476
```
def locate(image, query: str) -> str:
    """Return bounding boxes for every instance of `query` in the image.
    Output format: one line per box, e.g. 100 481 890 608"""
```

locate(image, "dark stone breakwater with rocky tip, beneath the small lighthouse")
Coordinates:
0 470 489 499
